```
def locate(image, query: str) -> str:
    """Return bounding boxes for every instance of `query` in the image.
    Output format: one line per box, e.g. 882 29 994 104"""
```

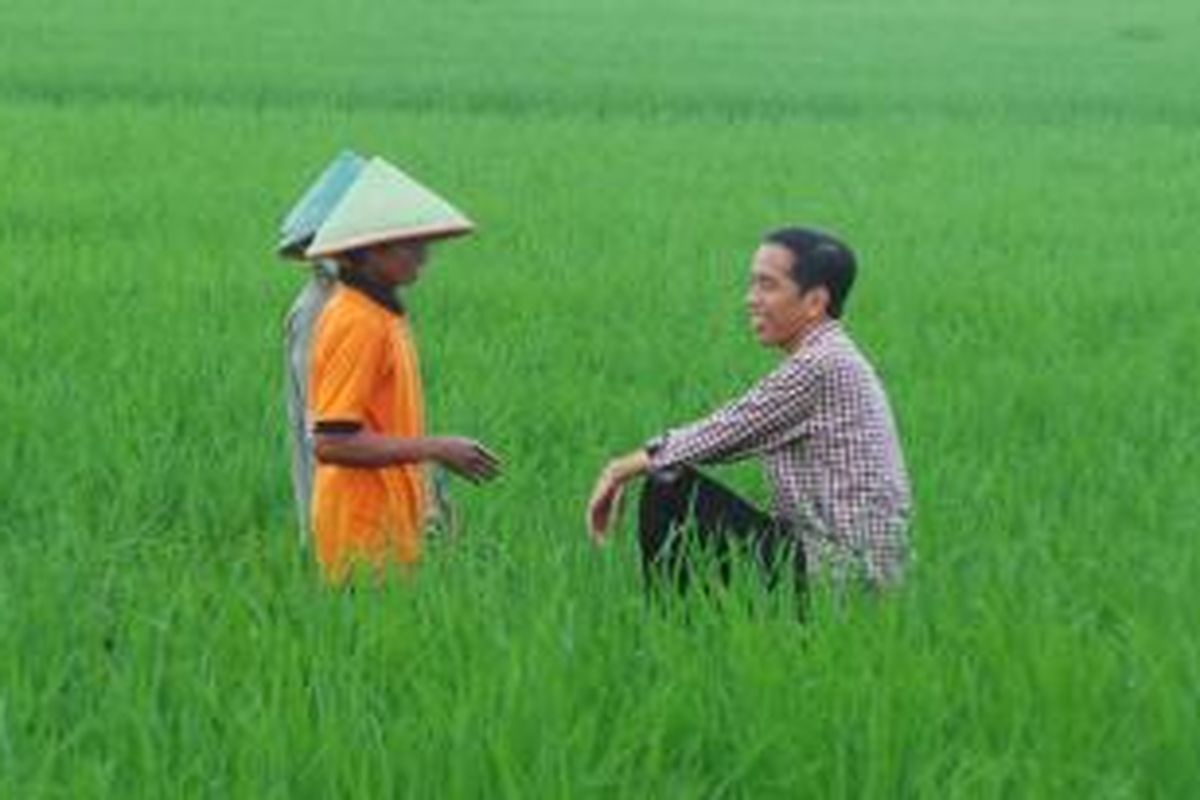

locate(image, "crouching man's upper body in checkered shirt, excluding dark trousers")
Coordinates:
588 228 911 588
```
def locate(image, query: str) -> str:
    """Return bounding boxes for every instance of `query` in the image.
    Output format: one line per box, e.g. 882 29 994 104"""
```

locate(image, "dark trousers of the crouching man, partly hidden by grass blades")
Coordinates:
637 467 805 596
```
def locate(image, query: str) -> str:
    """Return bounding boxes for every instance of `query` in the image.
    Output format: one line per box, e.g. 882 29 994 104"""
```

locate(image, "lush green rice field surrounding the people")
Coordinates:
0 0 1200 799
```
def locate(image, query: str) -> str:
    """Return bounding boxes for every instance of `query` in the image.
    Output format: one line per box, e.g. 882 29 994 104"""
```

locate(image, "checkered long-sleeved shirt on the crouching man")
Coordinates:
648 320 911 587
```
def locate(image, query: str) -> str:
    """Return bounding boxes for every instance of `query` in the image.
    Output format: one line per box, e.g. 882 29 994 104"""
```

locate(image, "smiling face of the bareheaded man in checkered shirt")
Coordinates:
746 243 829 350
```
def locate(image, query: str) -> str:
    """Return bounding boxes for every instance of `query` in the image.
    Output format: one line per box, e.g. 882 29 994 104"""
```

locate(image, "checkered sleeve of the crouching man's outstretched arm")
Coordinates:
648 359 821 469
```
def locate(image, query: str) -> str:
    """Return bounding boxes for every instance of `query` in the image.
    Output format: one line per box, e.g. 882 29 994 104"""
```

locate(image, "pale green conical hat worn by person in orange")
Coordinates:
305 158 475 259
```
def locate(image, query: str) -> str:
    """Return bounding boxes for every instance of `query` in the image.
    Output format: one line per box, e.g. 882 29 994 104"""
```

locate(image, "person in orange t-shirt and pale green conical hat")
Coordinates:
306 158 499 583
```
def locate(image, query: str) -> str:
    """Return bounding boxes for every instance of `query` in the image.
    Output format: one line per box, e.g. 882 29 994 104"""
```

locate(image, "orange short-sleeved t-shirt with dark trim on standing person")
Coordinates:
308 285 425 582
